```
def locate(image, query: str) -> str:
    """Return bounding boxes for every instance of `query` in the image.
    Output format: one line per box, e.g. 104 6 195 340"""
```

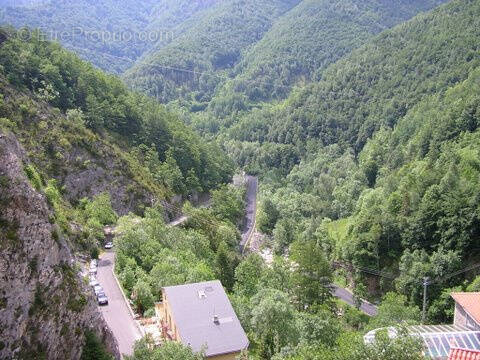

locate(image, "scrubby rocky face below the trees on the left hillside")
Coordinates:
0 77 166 215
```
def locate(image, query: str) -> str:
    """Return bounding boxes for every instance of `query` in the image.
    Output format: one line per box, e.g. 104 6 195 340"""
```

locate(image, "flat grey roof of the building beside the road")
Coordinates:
163 280 249 356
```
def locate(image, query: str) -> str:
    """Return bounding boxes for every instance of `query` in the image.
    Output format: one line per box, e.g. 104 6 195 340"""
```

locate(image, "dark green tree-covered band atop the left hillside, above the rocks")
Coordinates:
0 27 232 202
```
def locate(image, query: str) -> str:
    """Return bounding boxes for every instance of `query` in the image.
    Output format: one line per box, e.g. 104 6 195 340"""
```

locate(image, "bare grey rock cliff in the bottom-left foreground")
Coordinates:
0 131 118 359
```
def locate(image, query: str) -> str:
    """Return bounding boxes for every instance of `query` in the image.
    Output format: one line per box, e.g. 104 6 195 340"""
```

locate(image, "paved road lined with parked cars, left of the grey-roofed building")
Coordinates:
97 251 141 355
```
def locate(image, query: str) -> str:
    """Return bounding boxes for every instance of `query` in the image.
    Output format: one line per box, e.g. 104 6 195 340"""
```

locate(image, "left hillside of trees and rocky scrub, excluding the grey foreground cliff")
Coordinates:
0 27 233 208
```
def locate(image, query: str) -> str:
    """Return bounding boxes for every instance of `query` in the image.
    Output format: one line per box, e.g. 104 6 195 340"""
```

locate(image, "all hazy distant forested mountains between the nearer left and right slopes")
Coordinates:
0 0 445 105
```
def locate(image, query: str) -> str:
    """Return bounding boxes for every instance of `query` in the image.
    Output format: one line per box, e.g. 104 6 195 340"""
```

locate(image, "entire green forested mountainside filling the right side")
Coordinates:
244 1 480 321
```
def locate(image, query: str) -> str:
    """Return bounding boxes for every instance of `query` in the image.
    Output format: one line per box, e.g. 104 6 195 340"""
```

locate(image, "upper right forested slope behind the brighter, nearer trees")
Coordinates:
225 1 480 176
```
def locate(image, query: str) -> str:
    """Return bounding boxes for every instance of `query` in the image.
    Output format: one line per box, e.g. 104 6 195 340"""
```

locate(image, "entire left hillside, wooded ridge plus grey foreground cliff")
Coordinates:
0 25 233 360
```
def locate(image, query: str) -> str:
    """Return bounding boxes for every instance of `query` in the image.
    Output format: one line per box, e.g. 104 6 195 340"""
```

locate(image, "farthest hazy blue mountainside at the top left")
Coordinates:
0 0 218 73
